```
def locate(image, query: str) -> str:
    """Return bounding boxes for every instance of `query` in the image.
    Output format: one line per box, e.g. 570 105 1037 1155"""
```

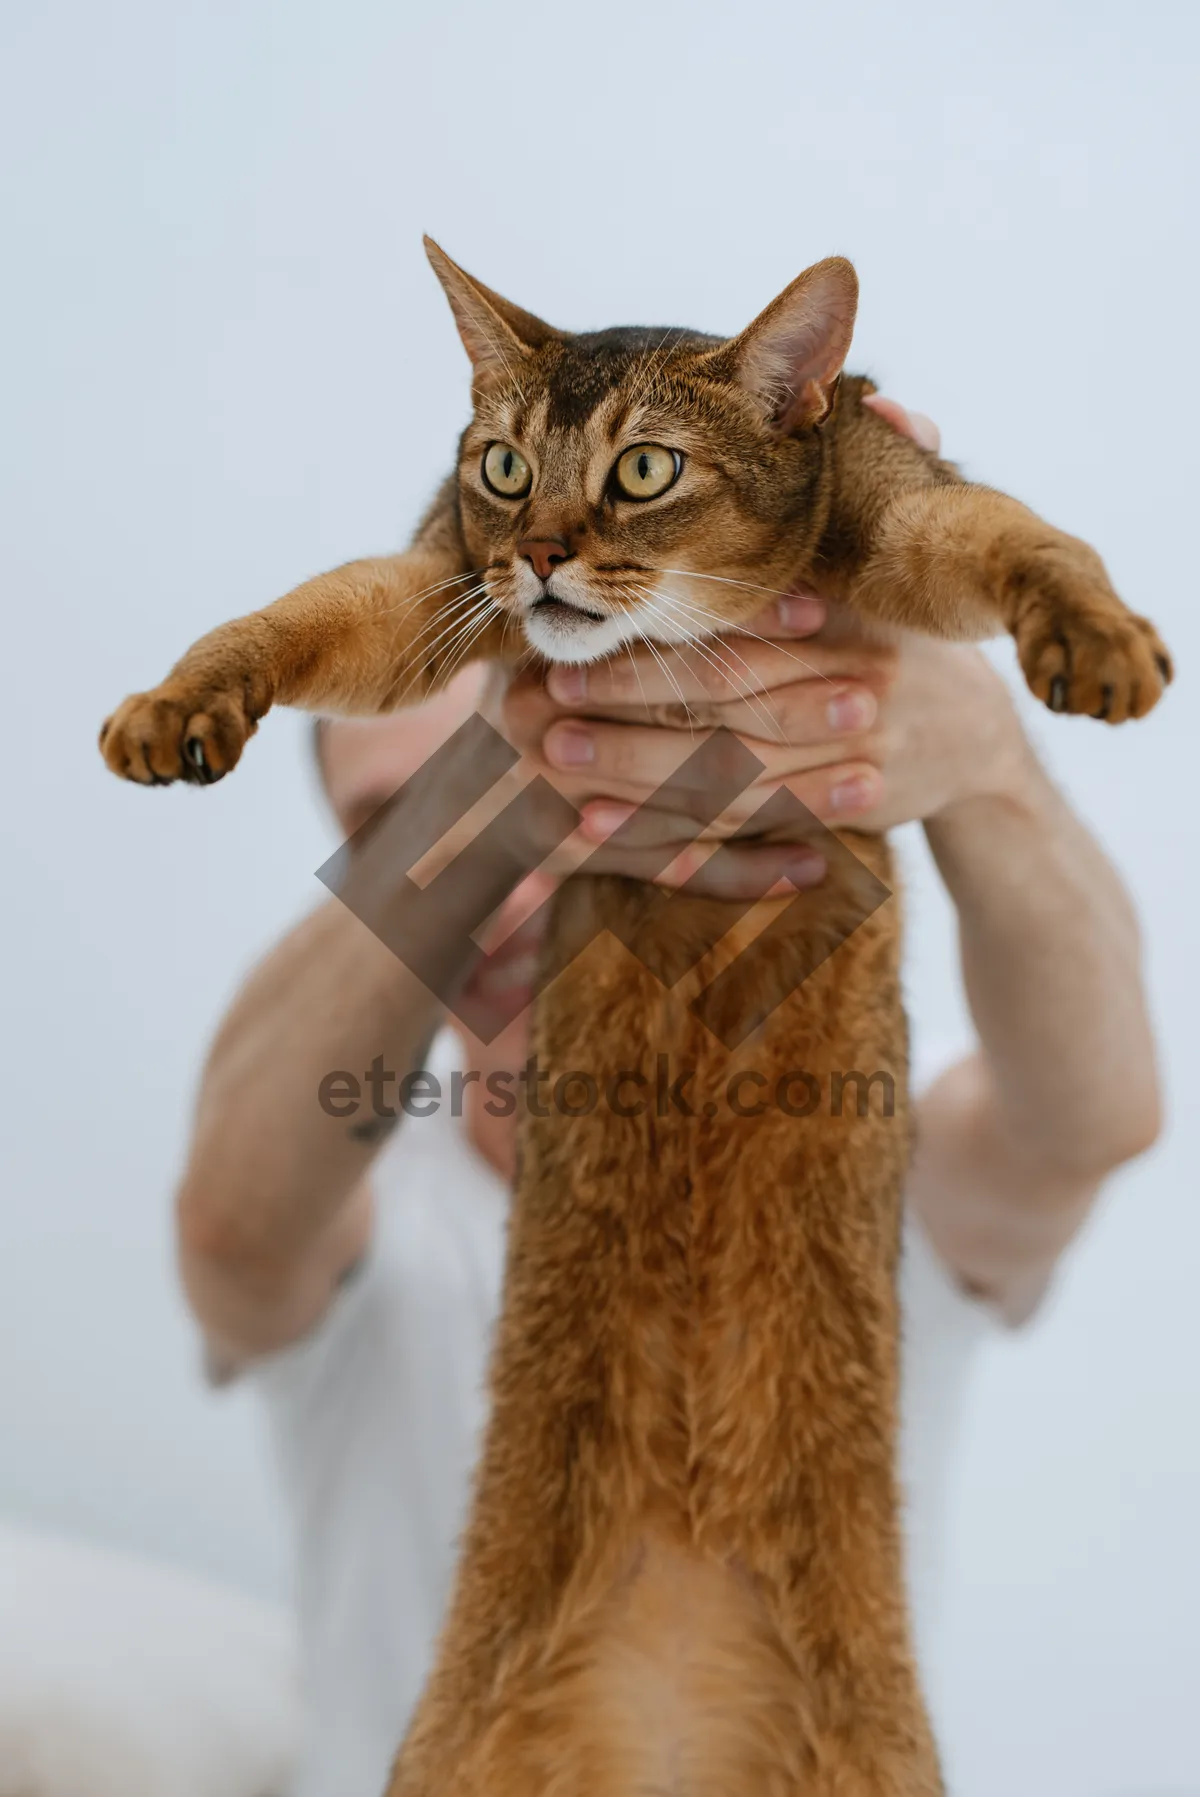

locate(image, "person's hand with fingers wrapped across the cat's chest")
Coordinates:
492 395 1024 891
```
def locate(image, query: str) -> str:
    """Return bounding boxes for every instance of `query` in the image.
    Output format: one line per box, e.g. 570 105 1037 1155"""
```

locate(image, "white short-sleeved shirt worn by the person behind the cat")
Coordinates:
255 1033 988 1797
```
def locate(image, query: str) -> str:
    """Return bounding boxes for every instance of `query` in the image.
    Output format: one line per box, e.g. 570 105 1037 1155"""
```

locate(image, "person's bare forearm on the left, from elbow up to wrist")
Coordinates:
178 779 521 1351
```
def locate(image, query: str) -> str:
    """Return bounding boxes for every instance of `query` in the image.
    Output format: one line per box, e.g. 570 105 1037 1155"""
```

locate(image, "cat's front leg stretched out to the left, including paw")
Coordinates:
101 541 505 785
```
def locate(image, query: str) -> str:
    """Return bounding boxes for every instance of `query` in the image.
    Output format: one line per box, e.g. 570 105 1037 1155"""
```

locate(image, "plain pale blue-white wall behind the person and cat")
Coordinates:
0 0 1200 1797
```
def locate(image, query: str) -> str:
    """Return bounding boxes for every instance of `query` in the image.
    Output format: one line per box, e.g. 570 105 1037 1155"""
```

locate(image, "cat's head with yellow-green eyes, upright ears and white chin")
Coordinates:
426 239 857 661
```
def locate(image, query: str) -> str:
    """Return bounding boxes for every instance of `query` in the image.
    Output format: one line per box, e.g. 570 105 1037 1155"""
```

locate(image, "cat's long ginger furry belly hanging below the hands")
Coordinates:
392 845 940 1797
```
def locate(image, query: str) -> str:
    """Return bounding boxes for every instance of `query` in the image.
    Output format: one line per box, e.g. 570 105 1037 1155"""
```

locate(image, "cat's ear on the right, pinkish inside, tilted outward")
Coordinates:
720 255 859 433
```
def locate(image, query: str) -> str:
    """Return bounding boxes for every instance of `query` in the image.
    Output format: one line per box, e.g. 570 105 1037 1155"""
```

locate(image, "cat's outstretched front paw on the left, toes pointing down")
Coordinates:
101 681 257 785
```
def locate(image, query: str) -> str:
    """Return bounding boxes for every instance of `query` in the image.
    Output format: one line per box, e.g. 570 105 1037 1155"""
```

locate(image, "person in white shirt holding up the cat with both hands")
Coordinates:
178 399 1159 1797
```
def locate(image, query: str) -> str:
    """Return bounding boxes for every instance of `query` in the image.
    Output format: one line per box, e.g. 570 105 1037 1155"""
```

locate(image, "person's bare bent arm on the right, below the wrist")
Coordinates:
911 753 1160 1323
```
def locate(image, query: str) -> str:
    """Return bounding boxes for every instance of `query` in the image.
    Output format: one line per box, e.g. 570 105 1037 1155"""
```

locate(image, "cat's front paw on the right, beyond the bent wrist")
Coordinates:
1013 568 1171 724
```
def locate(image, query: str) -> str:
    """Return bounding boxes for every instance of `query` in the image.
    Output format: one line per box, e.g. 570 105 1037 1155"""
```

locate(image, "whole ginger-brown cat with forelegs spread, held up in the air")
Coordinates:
101 244 1171 1797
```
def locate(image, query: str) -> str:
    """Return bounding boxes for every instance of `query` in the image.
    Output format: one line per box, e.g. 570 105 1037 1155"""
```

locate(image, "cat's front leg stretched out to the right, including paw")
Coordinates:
851 485 1171 724
